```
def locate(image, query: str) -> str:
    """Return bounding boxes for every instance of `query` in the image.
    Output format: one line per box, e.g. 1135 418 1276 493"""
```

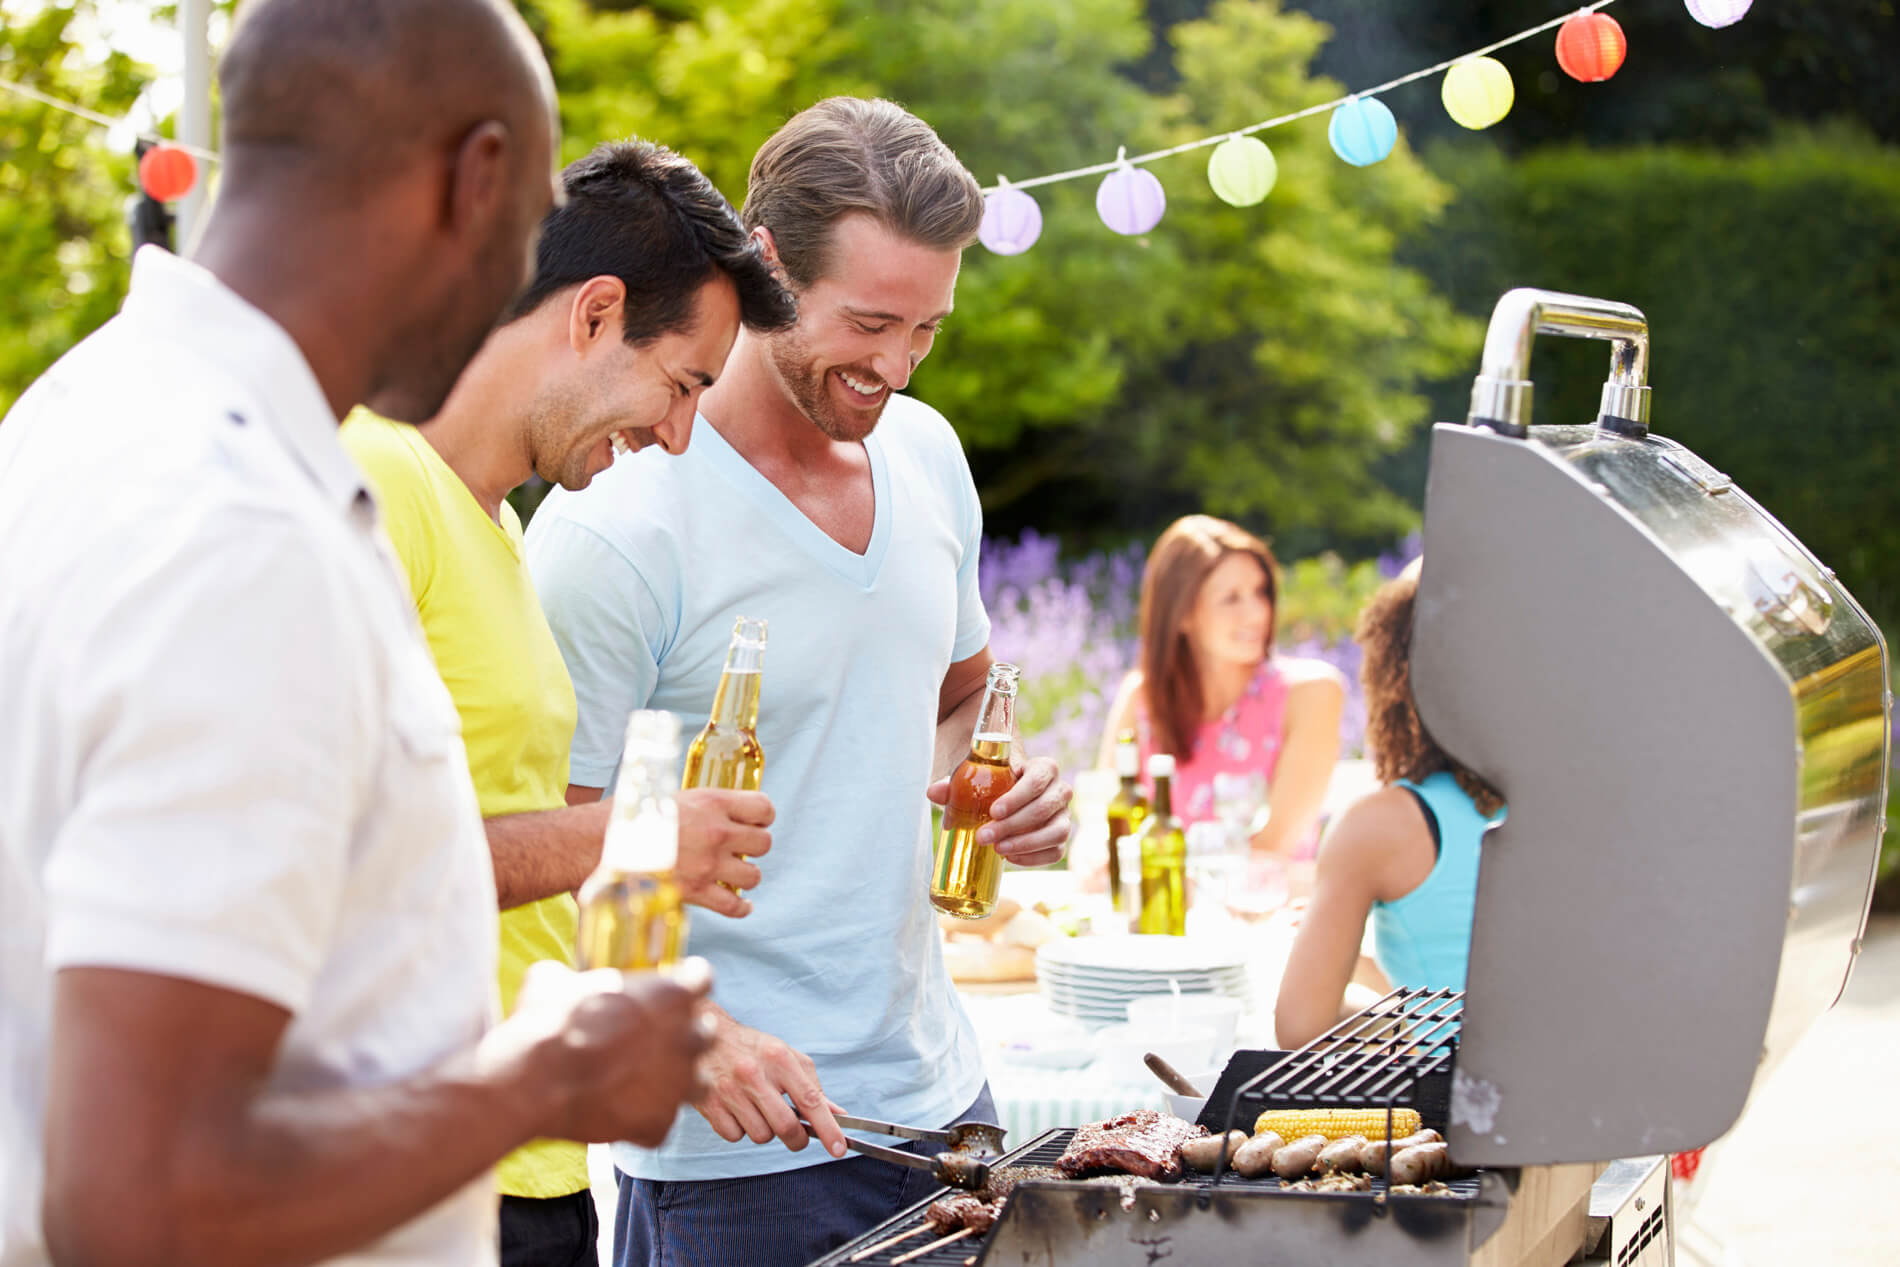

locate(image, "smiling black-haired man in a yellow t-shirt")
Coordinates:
342 142 794 1267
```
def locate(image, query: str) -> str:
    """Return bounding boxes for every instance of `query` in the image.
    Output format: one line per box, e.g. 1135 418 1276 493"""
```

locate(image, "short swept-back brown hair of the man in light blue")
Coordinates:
745 97 982 287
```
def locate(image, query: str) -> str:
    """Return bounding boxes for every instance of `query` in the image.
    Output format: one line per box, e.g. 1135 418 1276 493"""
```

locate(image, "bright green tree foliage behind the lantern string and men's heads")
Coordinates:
523 0 1476 541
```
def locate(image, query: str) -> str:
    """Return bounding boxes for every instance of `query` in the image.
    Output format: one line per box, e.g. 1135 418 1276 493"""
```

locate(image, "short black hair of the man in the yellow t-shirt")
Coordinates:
507 141 798 344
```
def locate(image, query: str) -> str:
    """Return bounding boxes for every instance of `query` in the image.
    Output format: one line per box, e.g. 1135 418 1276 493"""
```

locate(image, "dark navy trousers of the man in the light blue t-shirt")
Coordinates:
614 1087 996 1267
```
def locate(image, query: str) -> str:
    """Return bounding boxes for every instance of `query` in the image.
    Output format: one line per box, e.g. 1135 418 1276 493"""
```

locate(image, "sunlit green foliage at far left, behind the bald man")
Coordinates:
0 6 143 412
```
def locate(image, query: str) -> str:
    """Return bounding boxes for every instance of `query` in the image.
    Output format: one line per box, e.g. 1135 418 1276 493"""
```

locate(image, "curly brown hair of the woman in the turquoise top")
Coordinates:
1353 572 1505 817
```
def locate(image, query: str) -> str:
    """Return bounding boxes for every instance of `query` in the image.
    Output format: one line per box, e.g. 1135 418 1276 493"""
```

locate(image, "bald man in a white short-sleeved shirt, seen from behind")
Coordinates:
0 0 707 1267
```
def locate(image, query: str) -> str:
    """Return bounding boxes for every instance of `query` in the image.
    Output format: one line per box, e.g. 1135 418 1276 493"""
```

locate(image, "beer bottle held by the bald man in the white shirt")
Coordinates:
578 710 686 973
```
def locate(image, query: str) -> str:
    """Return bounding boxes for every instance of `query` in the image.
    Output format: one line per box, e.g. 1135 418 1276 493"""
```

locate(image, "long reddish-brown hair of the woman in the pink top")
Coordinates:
1138 515 1281 762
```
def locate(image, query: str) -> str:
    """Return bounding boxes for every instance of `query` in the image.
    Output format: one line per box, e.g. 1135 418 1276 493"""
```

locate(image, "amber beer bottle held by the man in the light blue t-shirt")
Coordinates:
931 665 1022 919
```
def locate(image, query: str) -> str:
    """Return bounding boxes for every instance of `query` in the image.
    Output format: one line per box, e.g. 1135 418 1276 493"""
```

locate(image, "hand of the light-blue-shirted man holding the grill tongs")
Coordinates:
694 1009 846 1157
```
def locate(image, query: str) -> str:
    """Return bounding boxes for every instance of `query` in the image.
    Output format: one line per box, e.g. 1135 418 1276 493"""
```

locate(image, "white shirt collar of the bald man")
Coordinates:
124 245 367 507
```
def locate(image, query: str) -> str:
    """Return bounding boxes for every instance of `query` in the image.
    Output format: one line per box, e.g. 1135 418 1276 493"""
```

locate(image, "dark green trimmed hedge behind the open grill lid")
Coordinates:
1404 129 1900 904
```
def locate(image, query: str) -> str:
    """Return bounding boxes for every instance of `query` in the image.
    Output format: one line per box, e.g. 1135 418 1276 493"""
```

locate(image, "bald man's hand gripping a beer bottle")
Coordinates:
477 959 714 1147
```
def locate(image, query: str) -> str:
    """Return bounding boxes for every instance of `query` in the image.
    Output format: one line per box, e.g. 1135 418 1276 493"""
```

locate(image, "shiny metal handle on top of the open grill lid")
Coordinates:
1465 287 1649 439
